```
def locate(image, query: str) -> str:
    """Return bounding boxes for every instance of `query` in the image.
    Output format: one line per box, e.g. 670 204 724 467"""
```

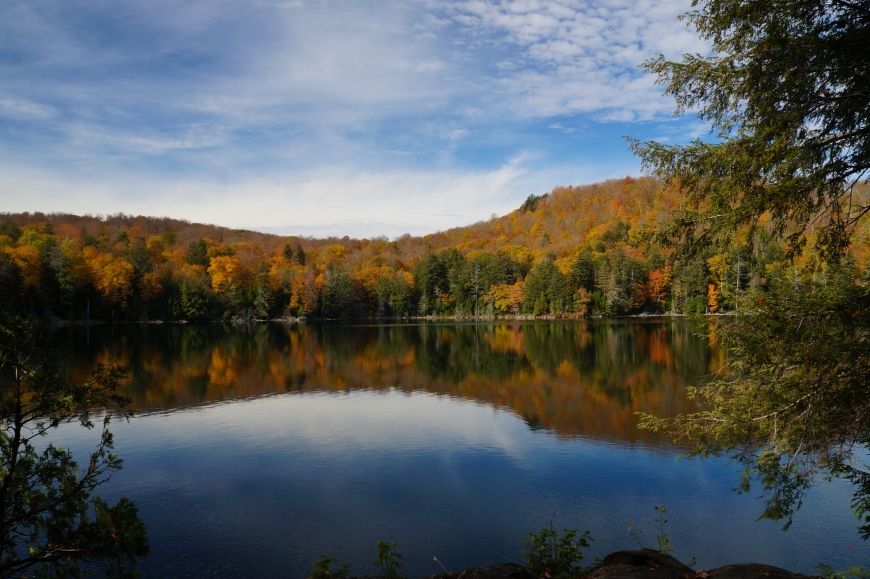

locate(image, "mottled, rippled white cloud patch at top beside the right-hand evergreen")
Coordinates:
437 0 707 121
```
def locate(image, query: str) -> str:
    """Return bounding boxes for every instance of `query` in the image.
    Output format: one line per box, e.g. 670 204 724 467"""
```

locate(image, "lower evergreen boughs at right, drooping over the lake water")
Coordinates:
641 263 870 538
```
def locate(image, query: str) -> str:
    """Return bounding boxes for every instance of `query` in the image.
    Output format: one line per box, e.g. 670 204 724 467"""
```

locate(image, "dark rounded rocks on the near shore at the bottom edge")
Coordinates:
350 549 810 579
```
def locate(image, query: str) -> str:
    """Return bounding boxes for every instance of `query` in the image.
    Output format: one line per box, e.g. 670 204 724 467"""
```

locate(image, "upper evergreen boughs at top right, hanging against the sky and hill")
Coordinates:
632 0 870 261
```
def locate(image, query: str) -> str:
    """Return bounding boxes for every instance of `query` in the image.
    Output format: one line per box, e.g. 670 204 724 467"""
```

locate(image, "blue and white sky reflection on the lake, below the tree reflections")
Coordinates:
51 327 870 578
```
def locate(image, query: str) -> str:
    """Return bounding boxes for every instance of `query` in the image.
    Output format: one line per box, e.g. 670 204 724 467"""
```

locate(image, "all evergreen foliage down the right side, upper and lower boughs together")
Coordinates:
632 0 870 539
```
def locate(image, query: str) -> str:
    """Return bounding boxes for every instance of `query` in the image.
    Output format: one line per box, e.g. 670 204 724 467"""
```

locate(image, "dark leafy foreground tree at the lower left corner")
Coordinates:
0 317 148 578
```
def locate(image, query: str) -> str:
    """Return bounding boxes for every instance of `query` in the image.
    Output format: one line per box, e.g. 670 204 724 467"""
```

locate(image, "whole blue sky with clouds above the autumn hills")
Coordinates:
0 0 707 237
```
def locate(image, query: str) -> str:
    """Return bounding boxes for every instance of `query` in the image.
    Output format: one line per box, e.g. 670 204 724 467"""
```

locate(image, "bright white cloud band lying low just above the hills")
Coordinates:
0 156 630 238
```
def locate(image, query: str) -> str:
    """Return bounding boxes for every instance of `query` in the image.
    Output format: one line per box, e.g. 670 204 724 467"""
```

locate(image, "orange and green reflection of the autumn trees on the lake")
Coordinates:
57 321 721 440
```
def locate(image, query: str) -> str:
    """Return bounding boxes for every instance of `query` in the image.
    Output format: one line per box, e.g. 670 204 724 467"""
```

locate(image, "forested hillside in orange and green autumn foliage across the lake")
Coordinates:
0 178 868 320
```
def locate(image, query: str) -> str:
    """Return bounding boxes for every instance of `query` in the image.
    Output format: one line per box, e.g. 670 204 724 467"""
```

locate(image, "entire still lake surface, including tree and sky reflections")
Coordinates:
55 320 870 579
